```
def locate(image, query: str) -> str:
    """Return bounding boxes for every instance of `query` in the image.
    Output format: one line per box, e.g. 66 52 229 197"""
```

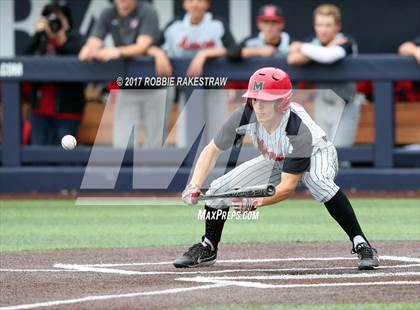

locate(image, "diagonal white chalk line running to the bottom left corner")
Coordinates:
0 283 227 310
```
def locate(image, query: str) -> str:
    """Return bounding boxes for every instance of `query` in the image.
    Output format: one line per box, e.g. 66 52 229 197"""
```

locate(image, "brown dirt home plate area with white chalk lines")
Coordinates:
0 241 420 309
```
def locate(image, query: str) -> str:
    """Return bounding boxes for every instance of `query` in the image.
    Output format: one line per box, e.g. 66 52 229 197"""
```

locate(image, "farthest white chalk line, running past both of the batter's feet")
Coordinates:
80 255 420 267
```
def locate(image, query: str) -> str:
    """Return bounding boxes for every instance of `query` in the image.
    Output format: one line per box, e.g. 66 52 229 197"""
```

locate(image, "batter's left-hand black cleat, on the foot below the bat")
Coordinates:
174 242 217 268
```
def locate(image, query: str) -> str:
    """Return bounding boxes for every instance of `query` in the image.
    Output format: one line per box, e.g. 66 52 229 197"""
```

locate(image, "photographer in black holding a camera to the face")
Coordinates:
24 4 85 145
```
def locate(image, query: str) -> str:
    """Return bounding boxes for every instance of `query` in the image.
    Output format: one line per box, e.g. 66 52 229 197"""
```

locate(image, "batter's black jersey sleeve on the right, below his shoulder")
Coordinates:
283 112 313 174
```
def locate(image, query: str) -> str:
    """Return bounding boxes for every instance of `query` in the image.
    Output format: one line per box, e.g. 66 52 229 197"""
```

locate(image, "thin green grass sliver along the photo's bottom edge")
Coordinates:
182 303 420 310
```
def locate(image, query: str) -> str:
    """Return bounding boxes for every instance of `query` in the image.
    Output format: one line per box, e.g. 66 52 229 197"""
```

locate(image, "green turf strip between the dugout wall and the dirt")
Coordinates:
0 199 420 252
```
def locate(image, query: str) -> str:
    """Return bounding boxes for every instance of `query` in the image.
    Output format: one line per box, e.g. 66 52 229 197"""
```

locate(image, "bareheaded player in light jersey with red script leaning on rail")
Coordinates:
154 0 235 146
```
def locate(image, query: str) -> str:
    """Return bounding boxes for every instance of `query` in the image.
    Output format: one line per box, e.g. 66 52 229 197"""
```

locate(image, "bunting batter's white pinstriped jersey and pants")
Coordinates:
210 103 339 203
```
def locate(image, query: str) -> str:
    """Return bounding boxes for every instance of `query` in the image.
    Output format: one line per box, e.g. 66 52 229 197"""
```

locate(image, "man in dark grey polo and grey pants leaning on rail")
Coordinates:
79 0 171 148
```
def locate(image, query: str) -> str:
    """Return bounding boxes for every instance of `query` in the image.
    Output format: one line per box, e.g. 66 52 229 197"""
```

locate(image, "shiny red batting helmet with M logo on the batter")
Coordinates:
242 67 293 112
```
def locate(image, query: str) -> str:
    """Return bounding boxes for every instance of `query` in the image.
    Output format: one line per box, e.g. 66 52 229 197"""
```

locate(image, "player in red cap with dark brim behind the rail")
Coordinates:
228 4 291 60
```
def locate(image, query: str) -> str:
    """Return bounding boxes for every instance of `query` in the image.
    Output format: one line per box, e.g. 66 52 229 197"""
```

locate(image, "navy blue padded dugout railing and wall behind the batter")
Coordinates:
0 54 420 193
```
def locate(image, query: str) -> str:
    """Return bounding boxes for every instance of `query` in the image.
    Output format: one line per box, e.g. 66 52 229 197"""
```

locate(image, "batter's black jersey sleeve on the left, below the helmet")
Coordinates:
213 104 255 151
